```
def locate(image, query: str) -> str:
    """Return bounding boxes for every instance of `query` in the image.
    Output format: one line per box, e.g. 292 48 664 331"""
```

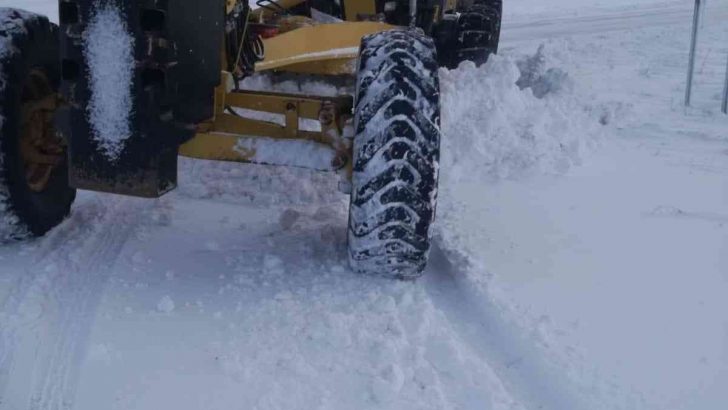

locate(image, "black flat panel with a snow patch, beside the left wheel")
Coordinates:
57 0 225 197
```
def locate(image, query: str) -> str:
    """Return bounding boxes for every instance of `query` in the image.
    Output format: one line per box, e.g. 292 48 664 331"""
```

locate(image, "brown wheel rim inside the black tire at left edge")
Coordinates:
20 70 66 192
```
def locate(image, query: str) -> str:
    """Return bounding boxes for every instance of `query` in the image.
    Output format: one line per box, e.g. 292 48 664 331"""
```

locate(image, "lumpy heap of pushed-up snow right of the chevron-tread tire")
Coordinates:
440 43 601 185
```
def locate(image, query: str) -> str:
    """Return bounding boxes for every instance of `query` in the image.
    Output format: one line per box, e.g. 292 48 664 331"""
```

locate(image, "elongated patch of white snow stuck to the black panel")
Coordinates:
84 4 134 161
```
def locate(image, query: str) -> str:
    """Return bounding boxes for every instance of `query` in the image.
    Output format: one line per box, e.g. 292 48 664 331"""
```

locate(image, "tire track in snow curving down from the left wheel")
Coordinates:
0 198 151 409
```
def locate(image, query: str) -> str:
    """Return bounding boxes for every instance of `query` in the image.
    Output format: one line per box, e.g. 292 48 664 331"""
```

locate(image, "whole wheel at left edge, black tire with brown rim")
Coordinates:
0 9 76 241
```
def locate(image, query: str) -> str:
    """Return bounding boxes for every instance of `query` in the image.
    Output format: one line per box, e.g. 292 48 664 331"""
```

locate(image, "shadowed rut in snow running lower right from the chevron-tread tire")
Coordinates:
423 242 588 410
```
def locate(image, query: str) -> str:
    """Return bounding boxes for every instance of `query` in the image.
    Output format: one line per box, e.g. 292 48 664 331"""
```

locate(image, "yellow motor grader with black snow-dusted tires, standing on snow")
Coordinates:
0 0 502 279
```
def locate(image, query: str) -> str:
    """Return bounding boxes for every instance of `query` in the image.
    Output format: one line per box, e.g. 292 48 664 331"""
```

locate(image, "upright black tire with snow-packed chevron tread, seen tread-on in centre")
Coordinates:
348 30 440 279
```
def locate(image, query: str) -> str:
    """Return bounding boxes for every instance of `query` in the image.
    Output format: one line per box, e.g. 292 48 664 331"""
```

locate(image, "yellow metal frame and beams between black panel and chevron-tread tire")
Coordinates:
179 8 395 178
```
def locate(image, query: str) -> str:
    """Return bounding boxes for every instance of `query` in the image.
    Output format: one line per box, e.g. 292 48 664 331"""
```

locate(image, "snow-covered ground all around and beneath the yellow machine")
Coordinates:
0 0 728 410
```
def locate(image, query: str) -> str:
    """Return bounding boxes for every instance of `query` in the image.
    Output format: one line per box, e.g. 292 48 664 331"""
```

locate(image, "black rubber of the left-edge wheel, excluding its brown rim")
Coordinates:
0 9 76 241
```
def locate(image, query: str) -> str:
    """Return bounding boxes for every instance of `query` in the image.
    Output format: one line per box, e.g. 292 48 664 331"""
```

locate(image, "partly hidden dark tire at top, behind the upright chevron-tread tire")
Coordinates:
434 0 503 69
